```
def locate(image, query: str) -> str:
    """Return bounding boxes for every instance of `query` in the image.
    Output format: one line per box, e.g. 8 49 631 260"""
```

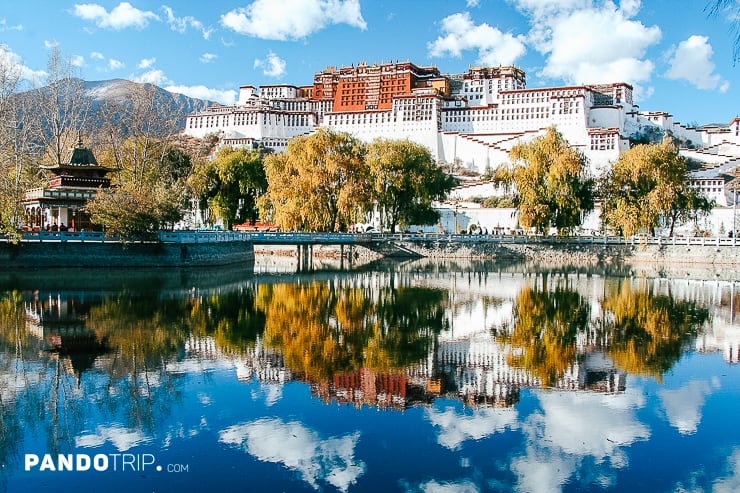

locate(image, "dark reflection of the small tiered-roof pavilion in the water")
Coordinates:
25 292 109 379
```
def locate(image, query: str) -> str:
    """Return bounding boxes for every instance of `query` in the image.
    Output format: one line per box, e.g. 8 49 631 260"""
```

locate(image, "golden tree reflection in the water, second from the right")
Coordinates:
499 281 590 385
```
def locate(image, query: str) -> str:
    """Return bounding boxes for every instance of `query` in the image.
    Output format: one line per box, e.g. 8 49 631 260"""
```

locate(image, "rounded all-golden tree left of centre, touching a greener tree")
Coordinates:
260 129 371 231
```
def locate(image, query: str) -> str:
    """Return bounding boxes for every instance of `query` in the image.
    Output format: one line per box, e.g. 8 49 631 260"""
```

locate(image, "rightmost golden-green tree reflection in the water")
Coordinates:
602 280 709 379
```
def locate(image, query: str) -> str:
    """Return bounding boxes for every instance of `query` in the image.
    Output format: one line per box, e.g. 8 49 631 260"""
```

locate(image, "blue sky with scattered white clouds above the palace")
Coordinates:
0 0 740 124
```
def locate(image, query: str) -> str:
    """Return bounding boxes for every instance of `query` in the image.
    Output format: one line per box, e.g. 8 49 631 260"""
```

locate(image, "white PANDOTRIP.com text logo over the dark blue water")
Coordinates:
24 454 190 473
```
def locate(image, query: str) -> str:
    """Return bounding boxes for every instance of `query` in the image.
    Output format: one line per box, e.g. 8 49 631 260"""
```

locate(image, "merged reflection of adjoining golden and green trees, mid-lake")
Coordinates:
257 283 443 381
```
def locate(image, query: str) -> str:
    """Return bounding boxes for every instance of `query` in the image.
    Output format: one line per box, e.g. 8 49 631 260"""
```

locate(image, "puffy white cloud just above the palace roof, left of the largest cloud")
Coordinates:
427 12 526 65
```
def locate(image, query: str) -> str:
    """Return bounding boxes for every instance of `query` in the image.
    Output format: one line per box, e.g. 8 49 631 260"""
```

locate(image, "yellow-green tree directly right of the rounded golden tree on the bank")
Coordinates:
367 139 454 232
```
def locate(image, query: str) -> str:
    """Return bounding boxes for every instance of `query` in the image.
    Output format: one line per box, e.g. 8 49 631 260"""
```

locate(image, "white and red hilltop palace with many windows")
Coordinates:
185 61 740 234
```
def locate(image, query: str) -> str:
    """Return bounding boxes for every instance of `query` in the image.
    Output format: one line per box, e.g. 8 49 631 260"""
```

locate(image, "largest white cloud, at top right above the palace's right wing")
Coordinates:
513 0 662 95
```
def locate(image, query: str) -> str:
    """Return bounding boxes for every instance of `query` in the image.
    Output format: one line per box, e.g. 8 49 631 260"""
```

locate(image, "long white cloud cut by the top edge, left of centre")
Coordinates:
221 0 367 41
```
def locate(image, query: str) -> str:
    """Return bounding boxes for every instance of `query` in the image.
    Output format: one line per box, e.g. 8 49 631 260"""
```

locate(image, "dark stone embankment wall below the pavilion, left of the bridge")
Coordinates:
0 241 254 268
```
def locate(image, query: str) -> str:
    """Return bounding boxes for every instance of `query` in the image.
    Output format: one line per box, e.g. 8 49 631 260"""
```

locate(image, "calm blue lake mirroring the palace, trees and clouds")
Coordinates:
0 260 740 493
